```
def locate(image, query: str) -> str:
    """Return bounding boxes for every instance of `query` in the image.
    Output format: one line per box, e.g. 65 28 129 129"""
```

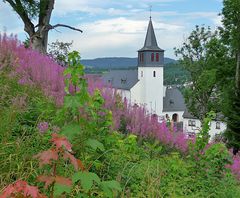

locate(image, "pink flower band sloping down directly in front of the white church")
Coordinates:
88 76 188 153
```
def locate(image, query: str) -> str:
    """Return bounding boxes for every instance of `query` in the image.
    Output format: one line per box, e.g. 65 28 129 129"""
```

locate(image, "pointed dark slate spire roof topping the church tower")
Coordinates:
139 18 164 51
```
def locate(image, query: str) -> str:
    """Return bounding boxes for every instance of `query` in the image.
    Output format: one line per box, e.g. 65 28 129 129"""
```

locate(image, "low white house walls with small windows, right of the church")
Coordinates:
183 118 227 139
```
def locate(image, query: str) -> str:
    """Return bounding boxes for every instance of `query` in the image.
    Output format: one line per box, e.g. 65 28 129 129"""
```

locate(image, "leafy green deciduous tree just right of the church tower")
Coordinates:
175 26 231 121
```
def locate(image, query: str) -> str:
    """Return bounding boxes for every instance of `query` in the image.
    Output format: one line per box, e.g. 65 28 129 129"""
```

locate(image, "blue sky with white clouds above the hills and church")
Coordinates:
0 0 222 59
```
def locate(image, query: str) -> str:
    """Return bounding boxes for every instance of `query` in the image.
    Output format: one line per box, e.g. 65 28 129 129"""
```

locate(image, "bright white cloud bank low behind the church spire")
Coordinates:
47 17 183 58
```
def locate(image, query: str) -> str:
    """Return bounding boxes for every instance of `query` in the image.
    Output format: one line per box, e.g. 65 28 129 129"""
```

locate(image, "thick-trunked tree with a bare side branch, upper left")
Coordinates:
3 0 82 53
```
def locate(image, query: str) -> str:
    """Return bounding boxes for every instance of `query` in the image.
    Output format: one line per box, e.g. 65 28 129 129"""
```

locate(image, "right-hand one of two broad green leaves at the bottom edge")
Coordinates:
100 180 122 197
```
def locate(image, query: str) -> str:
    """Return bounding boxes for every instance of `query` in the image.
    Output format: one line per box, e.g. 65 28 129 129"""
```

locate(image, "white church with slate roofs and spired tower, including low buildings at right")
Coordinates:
102 17 226 137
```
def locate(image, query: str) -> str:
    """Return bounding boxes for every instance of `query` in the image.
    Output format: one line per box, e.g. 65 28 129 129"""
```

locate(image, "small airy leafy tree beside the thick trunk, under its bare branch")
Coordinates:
48 40 73 66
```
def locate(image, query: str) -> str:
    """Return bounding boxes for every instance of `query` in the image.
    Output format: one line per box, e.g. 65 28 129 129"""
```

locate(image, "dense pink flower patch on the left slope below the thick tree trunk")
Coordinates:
0 34 64 105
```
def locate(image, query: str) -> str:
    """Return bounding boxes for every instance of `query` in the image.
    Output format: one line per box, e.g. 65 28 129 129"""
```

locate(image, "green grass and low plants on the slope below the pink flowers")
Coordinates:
0 67 240 198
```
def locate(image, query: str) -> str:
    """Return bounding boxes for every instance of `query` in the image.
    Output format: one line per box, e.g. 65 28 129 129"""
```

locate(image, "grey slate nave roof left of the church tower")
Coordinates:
102 70 138 90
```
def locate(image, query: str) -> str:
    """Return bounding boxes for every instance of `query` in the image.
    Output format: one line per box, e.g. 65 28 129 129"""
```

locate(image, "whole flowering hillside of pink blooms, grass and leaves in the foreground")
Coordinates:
0 35 240 198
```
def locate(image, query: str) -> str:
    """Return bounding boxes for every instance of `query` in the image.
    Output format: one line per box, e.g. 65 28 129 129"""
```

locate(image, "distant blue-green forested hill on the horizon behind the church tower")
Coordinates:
81 57 177 69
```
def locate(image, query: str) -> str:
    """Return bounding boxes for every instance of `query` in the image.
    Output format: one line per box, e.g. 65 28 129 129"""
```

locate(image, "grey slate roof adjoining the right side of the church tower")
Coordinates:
163 88 186 112
